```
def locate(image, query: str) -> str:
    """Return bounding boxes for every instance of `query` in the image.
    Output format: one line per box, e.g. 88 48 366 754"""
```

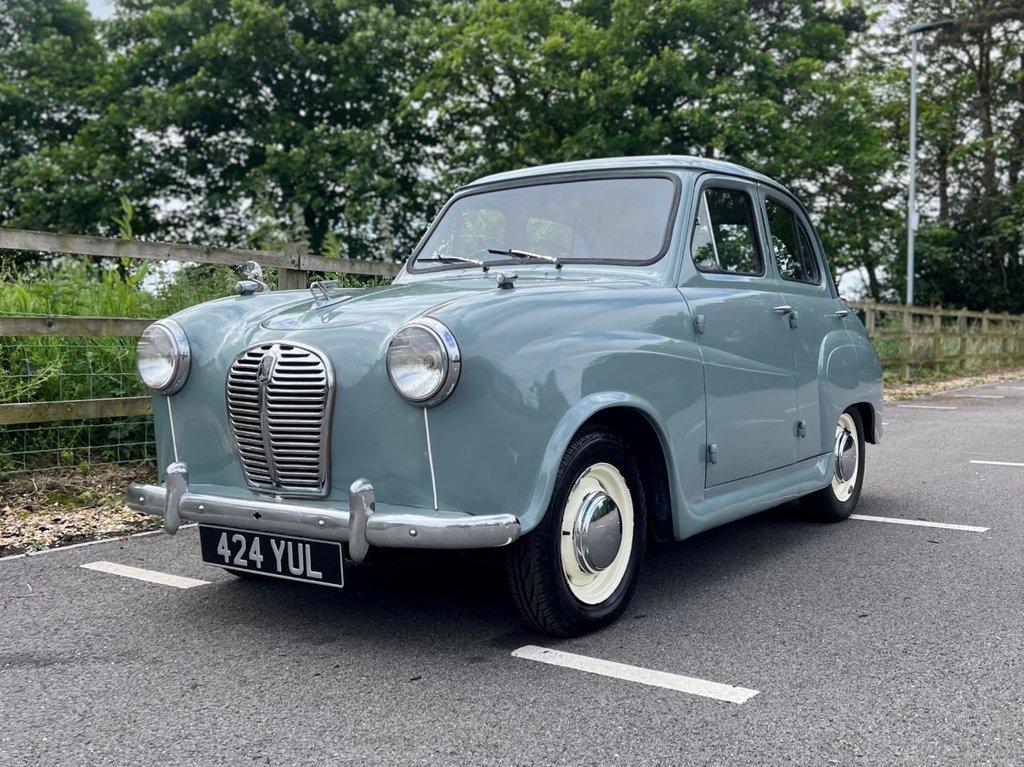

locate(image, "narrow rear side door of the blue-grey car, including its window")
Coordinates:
760 185 847 461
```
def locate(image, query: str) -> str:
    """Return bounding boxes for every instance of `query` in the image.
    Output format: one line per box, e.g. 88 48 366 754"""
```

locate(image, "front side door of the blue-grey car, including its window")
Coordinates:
680 175 797 486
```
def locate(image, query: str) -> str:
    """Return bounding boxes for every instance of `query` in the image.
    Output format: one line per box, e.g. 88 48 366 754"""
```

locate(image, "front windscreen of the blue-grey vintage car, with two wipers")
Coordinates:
413 176 676 268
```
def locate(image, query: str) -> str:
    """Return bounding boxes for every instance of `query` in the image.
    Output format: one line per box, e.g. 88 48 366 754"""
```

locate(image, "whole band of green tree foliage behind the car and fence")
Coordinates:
0 0 1024 310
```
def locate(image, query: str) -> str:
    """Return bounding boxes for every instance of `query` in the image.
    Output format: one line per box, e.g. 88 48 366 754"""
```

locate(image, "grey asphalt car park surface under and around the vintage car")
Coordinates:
0 382 1024 767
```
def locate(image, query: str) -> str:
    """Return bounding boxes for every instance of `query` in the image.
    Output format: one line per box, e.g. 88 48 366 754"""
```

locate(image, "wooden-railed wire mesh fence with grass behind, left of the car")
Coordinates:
0 227 400 485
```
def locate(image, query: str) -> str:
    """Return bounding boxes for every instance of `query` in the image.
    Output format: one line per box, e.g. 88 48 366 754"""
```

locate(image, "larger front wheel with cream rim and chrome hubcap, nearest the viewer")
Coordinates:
508 426 647 637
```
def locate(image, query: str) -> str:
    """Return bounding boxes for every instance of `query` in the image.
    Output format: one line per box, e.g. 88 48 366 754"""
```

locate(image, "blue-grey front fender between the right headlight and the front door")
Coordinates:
428 287 706 531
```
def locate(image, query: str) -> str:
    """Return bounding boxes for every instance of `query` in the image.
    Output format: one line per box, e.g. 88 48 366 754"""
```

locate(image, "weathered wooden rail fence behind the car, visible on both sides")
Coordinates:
6 228 1024 434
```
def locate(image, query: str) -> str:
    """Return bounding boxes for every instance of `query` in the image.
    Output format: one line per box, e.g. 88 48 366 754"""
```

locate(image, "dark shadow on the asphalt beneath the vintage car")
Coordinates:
167 504 827 651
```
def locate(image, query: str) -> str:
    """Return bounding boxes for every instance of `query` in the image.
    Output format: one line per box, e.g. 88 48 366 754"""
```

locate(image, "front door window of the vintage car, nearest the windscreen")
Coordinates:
691 188 765 276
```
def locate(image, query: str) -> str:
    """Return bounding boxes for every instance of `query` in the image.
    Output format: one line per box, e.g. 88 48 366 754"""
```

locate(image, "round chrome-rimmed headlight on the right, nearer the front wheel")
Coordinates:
387 317 462 408
